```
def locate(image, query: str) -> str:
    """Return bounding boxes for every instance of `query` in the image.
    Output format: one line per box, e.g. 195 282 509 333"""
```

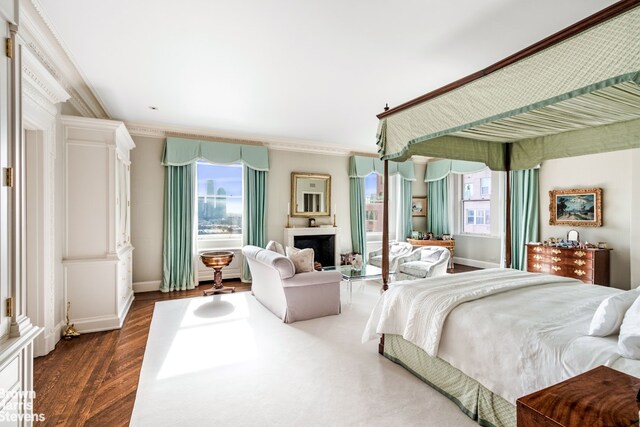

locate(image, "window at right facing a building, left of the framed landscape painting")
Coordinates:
462 168 491 234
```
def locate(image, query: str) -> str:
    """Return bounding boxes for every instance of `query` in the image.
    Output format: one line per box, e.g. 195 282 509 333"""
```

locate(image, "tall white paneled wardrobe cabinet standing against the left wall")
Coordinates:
61 116 135 332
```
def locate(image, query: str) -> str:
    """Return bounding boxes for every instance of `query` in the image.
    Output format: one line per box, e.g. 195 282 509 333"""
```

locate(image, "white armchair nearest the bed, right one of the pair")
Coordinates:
396 246 451 280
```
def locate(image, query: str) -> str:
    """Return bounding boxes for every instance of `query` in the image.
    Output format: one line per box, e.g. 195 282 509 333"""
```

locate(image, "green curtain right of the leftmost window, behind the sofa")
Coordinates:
242 165 267 282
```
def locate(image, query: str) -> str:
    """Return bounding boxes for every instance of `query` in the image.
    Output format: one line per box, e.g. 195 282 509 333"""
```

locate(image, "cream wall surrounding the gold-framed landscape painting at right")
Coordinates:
540 149 640 289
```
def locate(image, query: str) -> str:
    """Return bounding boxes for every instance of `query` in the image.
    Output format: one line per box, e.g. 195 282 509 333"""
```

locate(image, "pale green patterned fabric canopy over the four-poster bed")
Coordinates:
377 6 640 170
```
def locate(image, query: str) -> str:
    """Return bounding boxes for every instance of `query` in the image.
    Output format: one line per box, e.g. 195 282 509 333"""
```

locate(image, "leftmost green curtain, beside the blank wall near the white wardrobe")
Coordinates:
160 164 196 292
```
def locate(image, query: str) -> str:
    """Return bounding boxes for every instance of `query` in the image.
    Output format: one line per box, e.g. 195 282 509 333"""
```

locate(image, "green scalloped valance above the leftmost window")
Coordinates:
162 137 269 171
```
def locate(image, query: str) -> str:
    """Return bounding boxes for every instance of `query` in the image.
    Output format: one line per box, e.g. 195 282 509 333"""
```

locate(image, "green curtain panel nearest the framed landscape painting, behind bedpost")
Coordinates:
510 169 540 270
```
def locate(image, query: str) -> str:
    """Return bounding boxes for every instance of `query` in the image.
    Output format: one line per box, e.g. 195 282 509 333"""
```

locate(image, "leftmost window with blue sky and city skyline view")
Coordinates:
197 162 242 237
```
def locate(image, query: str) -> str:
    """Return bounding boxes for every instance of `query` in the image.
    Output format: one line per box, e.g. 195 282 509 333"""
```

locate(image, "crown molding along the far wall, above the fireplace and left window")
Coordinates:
125 122 376 156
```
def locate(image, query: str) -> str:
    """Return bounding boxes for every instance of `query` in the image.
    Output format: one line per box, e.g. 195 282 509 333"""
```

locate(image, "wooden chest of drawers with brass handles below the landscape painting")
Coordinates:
527 245 610 286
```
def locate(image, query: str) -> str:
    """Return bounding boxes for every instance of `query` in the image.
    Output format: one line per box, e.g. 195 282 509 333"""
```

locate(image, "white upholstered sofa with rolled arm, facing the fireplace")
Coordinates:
242 246 342 323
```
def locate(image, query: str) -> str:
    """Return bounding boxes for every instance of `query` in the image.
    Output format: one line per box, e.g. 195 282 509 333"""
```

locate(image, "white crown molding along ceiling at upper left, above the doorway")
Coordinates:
18 0 111 119
